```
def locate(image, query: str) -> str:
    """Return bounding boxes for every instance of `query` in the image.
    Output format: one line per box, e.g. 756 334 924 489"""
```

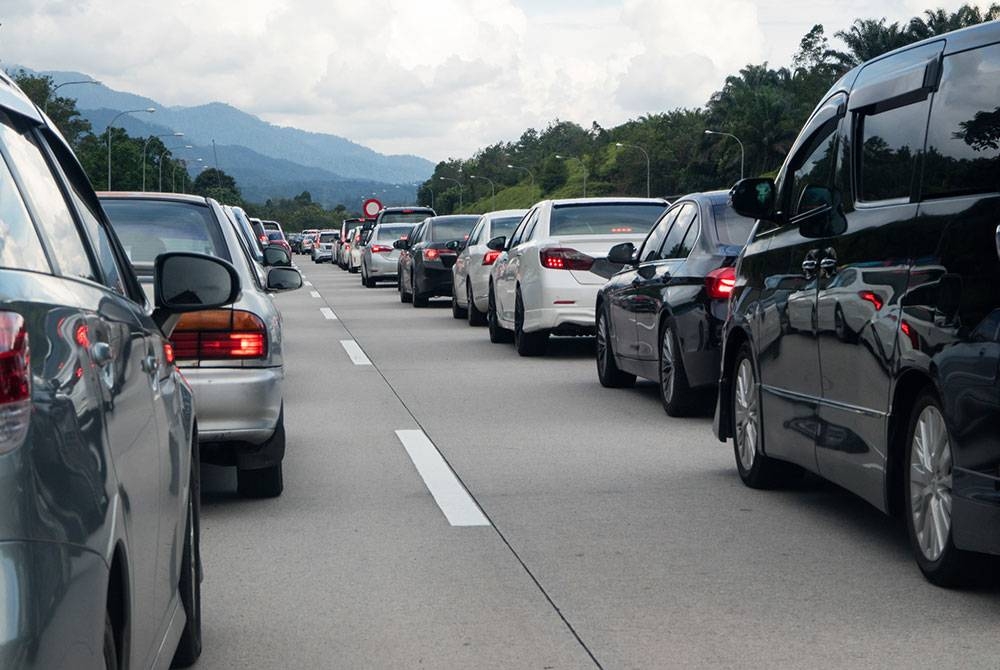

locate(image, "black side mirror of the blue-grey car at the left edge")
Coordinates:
153 251 241 337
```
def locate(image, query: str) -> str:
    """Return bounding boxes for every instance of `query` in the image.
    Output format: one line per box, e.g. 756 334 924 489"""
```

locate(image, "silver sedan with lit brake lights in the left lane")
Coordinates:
101 193 302 497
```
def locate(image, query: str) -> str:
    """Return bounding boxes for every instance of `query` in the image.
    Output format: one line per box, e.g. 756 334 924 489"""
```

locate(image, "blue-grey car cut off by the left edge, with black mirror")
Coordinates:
0 73 240 670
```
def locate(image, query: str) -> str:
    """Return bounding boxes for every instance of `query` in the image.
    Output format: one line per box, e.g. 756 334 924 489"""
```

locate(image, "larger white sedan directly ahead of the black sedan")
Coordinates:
486 198 669 356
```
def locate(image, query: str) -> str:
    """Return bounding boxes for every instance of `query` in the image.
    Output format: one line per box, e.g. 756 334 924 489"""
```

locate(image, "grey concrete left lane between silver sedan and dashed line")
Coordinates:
193 273 589 668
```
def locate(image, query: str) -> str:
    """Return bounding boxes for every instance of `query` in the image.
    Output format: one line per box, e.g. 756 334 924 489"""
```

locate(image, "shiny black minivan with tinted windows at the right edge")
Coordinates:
715 22 1000 585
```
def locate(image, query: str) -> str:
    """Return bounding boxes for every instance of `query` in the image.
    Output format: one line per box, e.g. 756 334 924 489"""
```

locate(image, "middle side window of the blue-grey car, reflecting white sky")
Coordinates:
0 118 97 281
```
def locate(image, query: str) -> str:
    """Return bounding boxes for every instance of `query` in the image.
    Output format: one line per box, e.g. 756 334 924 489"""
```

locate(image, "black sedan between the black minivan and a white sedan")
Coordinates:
595 191 753 416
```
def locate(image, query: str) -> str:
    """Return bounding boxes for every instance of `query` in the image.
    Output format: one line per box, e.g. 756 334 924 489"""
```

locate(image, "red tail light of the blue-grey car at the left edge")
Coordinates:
0 312 31 453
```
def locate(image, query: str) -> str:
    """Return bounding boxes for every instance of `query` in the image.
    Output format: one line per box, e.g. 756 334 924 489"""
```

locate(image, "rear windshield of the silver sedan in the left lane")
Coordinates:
101 200 231 263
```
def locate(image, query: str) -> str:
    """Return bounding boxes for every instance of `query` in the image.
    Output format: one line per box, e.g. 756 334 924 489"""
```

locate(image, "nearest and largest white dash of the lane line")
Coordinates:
396 430 490 526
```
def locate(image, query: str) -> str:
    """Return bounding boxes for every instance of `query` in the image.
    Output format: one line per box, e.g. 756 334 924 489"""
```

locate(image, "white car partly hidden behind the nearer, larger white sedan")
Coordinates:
451 209 528 326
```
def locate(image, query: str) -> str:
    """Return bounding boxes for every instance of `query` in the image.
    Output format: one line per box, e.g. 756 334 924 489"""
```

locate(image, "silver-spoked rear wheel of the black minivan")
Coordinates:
903 391 978 586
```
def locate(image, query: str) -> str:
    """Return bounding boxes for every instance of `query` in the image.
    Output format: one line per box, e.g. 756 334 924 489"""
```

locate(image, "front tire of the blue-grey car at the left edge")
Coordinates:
170 436 201 668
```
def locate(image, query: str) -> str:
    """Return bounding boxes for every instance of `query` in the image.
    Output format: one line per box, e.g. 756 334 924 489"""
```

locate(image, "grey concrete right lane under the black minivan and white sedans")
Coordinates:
318 272 998 667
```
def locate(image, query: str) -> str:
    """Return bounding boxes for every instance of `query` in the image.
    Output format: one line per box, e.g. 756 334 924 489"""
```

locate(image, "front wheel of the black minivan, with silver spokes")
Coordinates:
731 342 795 489
